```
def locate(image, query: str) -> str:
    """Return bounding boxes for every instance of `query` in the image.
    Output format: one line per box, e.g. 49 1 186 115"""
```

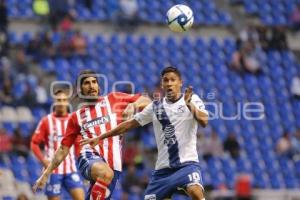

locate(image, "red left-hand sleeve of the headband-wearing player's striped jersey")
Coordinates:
61 113 80 147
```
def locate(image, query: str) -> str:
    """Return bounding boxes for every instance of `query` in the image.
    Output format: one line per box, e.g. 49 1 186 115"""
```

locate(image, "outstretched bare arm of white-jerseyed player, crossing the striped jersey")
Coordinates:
80 119 140 147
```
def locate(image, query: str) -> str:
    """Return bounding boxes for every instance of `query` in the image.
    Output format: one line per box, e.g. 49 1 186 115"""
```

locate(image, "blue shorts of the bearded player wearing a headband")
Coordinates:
77 152 121 199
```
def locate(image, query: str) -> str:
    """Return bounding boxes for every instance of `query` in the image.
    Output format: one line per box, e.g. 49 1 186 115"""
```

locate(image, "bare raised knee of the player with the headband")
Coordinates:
91 163 114 184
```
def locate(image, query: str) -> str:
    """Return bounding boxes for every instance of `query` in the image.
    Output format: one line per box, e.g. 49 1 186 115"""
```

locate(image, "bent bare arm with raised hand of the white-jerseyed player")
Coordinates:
184 86 208 127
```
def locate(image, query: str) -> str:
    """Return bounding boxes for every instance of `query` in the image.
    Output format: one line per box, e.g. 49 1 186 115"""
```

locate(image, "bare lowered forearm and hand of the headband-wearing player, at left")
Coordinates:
33 145 70 192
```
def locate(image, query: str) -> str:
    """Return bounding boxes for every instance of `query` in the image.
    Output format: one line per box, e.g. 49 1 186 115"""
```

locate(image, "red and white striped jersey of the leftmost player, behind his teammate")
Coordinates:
31 113 77 174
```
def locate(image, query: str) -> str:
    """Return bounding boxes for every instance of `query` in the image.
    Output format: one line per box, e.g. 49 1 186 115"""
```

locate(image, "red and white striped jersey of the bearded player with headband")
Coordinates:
62 92 140 171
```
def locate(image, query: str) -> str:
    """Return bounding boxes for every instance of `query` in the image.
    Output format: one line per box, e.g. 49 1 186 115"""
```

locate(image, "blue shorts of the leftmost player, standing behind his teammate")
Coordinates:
45 173 83 196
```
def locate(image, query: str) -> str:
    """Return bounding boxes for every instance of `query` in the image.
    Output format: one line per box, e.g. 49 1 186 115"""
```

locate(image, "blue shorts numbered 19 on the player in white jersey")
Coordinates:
145 162 203 200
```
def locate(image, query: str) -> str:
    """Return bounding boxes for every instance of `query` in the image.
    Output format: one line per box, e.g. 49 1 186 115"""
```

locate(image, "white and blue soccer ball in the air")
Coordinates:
167 4 194 33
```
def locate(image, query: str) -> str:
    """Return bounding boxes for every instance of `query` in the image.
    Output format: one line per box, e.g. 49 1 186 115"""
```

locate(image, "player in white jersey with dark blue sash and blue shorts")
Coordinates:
81 67 208 200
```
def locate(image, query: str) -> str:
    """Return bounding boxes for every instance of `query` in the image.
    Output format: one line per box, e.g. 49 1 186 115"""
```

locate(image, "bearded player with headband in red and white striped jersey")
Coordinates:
34 70 150 200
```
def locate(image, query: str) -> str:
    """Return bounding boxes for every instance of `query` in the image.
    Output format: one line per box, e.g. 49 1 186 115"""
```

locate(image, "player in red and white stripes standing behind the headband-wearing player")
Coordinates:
31 90 84 200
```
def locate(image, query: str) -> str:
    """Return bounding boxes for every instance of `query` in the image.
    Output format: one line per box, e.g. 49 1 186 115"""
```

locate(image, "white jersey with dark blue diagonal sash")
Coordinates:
134 94 208 170
